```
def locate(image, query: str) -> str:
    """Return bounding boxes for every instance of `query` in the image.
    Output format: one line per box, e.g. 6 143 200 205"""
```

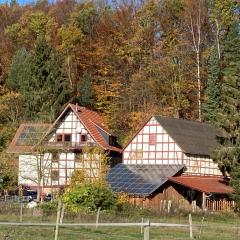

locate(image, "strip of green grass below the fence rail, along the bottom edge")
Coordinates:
0 226 240 240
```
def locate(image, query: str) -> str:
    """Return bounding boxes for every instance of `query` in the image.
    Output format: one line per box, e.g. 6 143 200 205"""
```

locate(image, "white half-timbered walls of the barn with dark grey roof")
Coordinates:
123 117 222 175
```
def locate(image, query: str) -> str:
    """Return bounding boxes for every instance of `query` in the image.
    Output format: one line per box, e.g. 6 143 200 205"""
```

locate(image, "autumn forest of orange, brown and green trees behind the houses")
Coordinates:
0 0 240 202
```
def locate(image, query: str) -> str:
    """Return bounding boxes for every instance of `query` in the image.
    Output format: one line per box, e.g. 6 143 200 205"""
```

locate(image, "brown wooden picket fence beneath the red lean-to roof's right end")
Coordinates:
206 199 235 212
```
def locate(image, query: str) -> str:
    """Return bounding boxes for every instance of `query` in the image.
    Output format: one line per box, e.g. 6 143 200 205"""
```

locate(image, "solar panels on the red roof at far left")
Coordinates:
16 126 48 146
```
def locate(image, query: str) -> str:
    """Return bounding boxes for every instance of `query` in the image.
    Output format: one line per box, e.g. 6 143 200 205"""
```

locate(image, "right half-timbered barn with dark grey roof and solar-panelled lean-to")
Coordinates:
108 116 232 210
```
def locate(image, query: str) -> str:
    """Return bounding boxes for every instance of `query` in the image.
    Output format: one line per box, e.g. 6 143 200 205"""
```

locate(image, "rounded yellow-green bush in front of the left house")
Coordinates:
63 183 117 212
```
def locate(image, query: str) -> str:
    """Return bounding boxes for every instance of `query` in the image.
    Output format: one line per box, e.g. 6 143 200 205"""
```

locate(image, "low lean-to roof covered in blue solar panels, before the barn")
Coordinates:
107 163 184 196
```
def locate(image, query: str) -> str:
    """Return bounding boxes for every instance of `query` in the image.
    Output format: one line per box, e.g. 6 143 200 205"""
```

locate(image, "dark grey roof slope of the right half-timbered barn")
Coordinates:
154 116 221 156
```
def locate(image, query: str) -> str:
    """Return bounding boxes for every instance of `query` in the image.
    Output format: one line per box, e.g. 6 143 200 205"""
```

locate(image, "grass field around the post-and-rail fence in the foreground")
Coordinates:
0 204 240 240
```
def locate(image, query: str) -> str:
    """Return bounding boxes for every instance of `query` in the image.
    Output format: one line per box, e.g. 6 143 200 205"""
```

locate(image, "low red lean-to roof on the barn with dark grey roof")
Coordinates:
169 176 234 194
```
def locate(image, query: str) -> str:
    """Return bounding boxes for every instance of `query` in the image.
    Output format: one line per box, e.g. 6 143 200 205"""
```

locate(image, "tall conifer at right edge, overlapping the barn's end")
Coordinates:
216 24 240 210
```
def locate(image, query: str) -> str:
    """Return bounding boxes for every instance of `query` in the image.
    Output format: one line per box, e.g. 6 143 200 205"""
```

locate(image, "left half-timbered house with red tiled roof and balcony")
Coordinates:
8 104 121 192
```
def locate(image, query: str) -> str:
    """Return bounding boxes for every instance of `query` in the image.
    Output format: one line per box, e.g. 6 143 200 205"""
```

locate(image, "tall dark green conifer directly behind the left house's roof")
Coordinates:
23 39 70 121
